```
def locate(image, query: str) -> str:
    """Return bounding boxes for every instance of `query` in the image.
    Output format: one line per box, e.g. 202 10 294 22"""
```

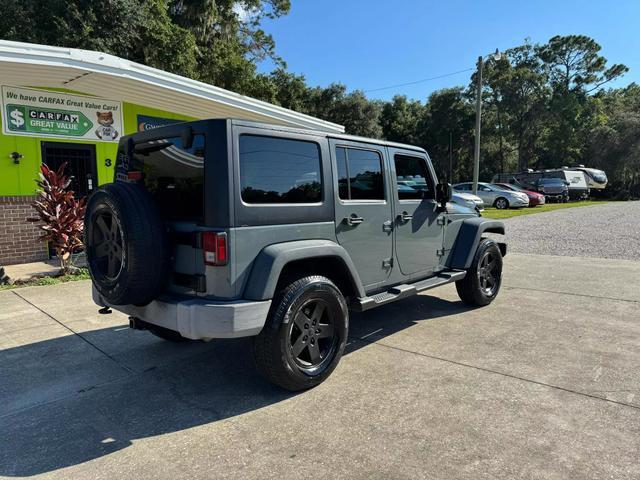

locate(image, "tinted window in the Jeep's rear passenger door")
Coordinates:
336 147 384 200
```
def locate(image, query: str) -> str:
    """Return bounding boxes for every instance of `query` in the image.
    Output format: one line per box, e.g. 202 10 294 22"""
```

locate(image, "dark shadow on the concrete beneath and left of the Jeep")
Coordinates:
0 295 466 476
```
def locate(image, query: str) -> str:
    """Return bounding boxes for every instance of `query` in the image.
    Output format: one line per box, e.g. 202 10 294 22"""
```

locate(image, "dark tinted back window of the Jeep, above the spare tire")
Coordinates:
128 135 205 222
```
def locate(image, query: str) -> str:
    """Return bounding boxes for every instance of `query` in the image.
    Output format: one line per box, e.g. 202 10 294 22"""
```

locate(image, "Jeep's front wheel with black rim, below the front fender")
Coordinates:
456 238 502 307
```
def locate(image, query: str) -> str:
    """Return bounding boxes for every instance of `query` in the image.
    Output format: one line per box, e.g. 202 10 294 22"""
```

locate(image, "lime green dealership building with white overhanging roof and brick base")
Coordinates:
0 40 344 265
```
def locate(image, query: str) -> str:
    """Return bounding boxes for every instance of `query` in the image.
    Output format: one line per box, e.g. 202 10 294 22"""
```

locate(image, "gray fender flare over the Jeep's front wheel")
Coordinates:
447 217 507 270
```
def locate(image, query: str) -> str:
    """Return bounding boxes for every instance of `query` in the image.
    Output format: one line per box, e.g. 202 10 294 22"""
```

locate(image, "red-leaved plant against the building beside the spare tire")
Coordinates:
29 162 86 273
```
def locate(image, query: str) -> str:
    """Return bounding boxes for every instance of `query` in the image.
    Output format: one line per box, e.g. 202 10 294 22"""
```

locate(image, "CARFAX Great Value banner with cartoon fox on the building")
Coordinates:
2 86 123 142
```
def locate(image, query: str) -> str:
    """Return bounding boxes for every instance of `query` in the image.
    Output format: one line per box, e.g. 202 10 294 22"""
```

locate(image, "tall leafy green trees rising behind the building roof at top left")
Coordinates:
0 0 290 98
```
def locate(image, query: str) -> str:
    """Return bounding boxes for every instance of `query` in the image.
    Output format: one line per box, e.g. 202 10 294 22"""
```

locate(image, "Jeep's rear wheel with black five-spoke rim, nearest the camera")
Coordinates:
253 275 349 391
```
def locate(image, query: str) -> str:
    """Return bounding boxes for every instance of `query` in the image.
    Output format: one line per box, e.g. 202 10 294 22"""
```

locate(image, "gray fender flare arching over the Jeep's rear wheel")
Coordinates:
243 240 365 300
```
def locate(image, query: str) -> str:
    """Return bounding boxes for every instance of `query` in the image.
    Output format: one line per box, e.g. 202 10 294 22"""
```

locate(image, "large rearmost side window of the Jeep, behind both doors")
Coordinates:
240 135 322 204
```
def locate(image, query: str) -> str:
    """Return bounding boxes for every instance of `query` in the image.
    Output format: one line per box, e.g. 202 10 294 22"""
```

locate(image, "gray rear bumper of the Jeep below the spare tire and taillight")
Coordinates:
92 288 271 340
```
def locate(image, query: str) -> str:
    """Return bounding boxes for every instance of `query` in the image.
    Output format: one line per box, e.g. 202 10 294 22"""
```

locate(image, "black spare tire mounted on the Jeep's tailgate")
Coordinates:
84 182 170 305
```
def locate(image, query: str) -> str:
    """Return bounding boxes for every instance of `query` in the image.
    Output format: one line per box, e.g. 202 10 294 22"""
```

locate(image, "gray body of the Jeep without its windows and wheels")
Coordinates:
102 120 504 338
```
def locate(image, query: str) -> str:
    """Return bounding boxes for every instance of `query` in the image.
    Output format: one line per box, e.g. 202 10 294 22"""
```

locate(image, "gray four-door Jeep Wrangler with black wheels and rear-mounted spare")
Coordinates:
85 119 506 390
